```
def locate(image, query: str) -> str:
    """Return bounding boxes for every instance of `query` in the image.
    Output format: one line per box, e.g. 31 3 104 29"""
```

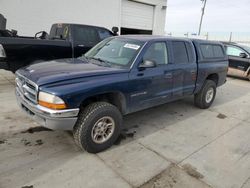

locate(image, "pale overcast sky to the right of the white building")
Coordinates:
166 0 250 33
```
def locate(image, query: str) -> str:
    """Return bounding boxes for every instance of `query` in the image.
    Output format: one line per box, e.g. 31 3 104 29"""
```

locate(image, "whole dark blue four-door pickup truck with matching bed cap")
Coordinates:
16 36 228 153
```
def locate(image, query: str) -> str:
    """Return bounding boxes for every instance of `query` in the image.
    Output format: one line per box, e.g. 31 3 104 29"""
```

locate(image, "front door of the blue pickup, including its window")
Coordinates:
130 41 172 112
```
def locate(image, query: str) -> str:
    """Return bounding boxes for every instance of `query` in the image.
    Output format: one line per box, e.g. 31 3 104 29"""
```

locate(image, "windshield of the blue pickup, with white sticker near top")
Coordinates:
85 38 143 67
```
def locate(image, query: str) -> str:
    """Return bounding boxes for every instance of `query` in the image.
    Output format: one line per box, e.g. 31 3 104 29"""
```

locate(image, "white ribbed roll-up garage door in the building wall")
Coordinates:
121 0 154 30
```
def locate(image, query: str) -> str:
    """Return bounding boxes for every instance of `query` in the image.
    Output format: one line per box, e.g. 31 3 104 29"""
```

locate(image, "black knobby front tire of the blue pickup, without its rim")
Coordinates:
73 102 122 153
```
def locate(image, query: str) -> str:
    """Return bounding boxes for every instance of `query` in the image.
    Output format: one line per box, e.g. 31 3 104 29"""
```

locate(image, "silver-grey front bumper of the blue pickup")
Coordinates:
16 87 79 130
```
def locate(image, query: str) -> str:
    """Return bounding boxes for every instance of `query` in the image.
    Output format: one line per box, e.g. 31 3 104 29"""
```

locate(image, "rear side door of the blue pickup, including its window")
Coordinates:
168 41 197 99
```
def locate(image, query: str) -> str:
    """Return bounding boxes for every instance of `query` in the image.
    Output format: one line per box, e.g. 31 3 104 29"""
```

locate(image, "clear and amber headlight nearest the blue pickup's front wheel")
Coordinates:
38 91 66 110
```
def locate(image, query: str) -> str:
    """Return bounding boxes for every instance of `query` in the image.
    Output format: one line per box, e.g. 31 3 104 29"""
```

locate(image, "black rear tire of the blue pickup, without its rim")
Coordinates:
194 80 216 109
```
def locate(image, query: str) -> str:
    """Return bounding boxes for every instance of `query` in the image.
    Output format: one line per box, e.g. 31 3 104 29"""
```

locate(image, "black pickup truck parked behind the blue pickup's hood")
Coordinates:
0 23 117 72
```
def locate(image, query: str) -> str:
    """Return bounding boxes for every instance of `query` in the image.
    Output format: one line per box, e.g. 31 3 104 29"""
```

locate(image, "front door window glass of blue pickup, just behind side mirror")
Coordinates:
143 42 168 65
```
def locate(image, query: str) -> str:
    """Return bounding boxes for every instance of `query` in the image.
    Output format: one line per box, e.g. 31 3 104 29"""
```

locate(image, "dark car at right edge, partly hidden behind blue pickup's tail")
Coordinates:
224 42 250 80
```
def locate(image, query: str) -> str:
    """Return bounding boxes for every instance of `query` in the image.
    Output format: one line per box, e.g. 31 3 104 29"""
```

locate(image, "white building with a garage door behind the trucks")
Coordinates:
0 0 167 36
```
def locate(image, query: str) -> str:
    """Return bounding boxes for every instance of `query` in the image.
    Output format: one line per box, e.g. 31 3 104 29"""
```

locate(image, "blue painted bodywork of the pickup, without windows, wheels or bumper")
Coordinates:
18 36 228 114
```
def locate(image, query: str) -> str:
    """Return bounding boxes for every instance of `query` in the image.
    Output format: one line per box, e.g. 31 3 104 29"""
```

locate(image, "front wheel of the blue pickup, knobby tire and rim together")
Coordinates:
73 102 122 153
